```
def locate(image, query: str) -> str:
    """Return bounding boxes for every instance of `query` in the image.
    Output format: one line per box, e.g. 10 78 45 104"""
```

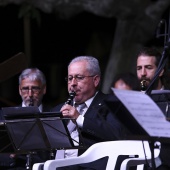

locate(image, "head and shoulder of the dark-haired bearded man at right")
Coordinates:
136 47 169 91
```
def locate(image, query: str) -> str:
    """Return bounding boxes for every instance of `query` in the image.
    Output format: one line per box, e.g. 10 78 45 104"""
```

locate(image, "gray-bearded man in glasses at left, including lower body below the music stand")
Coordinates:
0 68 51 170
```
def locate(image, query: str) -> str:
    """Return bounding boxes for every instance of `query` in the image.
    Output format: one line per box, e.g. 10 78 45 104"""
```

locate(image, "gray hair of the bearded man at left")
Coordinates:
19 68 46 85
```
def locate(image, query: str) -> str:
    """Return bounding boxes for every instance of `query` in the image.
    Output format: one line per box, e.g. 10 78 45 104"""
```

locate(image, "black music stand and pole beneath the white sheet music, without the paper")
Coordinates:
105 91 170 169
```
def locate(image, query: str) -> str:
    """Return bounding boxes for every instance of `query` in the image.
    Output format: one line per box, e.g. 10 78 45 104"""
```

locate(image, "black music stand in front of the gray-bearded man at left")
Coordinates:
2 107 82 169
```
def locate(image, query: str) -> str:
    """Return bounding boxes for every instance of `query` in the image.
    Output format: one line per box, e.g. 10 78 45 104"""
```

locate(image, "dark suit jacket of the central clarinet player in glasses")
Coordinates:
52 91 123 155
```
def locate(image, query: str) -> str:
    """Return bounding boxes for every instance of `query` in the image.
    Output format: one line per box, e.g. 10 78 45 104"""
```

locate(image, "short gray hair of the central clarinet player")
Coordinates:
68 56 101 76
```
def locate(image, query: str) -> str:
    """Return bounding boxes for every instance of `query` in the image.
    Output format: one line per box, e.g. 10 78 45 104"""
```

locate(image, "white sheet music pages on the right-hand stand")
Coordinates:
112 88 170 137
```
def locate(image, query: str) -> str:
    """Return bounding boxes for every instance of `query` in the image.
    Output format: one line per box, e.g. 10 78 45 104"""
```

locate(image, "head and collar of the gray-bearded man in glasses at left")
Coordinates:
19 68 48 109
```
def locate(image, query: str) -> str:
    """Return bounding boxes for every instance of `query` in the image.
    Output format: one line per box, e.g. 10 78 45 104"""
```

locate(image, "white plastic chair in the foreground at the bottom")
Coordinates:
32 140 161 170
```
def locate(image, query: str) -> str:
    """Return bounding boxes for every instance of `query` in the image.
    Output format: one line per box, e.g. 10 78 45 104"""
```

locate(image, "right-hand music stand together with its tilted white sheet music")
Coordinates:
105 89 170 169
